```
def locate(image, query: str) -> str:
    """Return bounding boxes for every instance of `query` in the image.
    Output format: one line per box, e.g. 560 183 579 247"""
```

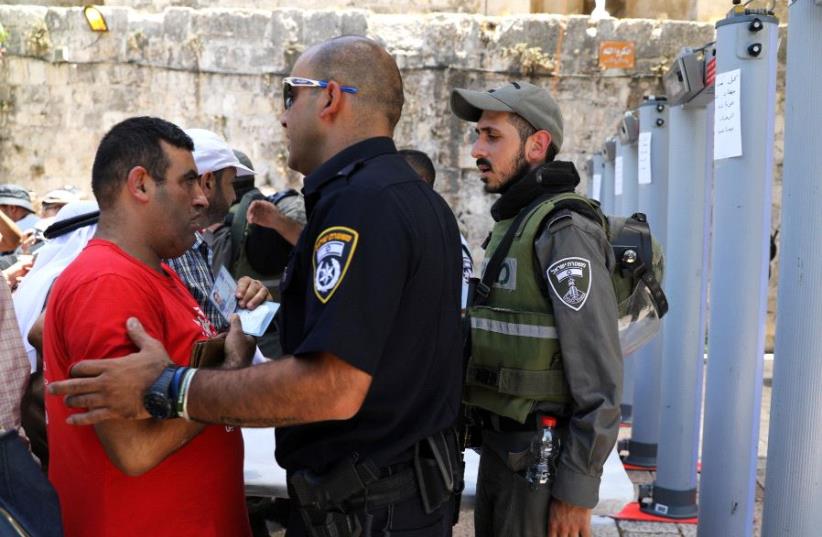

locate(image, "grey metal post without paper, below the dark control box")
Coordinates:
647 100 710 518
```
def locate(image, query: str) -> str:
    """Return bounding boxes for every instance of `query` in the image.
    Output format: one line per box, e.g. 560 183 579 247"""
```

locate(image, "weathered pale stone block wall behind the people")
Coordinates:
0 5 784 344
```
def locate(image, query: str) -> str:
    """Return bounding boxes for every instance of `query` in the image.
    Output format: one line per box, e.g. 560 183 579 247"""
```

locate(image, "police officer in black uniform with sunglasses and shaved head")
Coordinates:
51 36 462 537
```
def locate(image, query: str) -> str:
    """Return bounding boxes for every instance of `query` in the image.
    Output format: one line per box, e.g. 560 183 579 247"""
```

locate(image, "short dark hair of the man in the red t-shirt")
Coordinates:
91 116 194 208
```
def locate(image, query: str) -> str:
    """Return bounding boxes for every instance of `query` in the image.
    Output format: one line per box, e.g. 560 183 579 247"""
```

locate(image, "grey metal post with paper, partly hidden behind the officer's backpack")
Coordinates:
625 97 668 468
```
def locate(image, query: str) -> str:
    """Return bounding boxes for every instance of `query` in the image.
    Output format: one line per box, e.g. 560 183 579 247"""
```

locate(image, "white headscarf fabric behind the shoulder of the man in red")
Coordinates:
12 201 99 373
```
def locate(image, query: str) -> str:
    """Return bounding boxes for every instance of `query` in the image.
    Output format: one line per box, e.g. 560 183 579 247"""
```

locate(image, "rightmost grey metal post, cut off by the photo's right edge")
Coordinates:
762 0 822 537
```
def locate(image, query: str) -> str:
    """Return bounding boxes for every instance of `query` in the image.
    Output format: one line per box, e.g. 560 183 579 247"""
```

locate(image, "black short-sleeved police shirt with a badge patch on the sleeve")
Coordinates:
277 138 462 473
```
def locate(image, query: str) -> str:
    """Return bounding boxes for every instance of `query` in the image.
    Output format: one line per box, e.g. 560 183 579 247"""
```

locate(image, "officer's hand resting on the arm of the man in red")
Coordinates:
48 317 171 425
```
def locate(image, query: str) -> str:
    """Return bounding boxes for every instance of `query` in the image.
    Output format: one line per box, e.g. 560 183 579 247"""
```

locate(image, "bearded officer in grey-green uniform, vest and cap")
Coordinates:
451 82 622 537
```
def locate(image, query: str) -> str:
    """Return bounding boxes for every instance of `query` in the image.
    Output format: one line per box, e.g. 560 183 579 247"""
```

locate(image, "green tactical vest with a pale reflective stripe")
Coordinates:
465 194 579 423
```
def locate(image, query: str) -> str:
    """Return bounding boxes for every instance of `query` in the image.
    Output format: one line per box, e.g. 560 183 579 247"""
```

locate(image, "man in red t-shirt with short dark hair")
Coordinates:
44 117 253 537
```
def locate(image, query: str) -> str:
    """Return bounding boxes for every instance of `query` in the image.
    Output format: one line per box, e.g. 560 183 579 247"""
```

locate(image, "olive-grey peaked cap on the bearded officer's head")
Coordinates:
451 82 563 151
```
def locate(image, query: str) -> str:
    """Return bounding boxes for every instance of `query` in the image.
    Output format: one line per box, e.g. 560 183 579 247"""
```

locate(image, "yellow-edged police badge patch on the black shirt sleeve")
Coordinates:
313 226 359 304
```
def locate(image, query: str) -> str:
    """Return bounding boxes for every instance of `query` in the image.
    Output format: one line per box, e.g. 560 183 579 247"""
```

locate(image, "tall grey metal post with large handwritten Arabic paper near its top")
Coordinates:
698 6 778 537
